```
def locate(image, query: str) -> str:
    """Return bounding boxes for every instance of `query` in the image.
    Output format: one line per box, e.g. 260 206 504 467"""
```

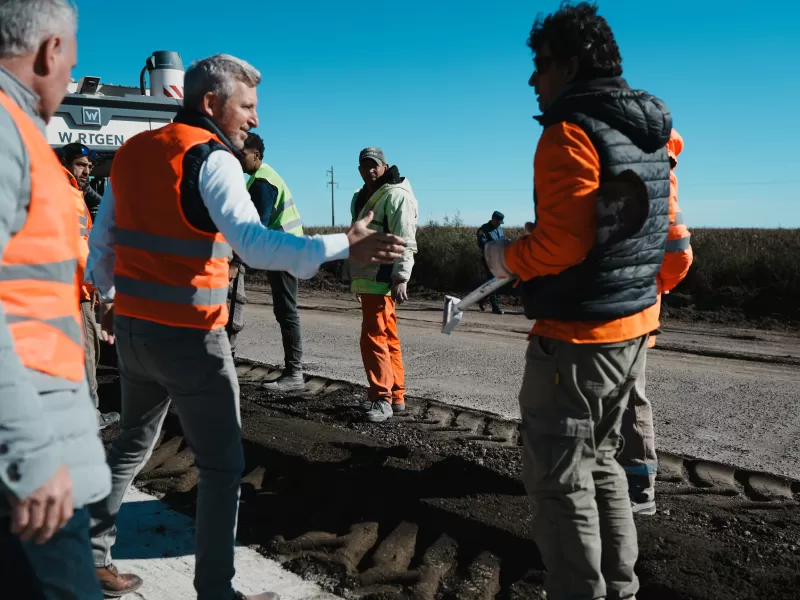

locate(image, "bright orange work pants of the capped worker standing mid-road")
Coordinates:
361 294 406 404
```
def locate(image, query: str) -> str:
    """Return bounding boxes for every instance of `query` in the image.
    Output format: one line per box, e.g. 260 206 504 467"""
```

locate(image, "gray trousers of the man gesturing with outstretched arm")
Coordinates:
91 316 244 600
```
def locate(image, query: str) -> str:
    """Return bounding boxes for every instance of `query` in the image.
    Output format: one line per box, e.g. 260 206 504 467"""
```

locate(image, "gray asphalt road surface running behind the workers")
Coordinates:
237 291 800 479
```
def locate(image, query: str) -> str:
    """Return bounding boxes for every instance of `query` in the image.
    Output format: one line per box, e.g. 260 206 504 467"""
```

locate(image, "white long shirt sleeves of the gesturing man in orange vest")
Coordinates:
84 150 350 302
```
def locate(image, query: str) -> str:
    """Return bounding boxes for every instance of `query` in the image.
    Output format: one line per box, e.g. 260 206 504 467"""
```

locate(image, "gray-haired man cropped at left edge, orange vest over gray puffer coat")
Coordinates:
0 0 110 600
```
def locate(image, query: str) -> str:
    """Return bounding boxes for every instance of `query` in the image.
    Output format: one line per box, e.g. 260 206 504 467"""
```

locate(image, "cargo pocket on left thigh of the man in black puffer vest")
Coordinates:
521 411 592 493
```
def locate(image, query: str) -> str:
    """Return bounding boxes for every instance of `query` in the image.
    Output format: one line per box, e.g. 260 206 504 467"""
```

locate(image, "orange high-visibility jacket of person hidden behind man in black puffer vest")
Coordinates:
647 128 694 348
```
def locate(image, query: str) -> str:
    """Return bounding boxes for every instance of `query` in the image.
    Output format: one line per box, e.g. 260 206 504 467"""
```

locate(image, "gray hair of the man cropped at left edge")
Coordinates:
0 0 78 58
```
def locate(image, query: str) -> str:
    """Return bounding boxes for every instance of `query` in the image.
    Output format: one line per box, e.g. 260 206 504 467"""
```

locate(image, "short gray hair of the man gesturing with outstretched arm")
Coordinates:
184 54 261 108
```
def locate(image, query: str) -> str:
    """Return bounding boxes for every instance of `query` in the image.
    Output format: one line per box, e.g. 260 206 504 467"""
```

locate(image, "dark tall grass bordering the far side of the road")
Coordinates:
276 225 800 322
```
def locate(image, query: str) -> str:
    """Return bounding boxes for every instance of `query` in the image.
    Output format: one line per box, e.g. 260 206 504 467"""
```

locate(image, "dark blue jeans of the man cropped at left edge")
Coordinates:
0 508 103 600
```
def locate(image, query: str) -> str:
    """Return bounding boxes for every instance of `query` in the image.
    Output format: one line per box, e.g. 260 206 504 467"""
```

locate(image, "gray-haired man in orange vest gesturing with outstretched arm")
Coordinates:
86 55 404 600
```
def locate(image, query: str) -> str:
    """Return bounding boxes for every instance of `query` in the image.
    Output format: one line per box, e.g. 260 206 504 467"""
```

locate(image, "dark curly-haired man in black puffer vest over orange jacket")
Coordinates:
485 2 672 600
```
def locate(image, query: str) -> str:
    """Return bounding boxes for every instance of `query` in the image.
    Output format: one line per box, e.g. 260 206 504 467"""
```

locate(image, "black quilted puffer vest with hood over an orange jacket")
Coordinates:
521 78 672 321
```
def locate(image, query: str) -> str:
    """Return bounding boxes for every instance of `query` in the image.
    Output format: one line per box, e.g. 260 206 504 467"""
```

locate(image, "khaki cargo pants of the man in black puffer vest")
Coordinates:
519 336 647 600
